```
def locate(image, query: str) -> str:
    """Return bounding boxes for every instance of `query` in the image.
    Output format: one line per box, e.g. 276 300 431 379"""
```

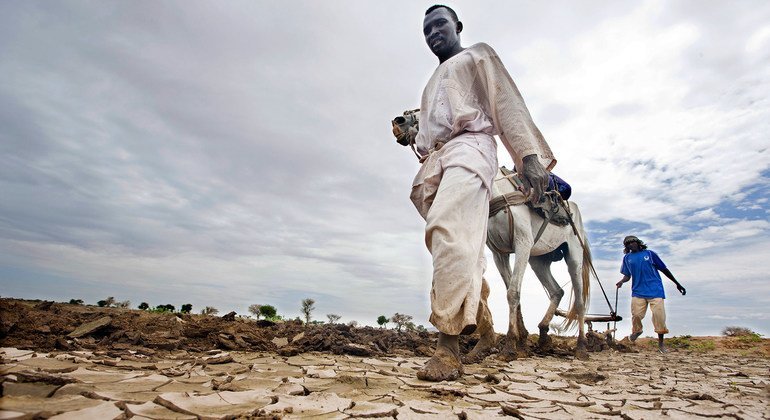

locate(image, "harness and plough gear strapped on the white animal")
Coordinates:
487 166 623 330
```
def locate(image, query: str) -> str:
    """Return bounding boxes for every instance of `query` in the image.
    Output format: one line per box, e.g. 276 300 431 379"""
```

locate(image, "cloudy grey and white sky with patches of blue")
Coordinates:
0 0 770 336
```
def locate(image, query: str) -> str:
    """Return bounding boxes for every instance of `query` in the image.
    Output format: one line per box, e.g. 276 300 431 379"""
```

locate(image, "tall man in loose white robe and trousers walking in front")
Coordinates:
411 5 556 381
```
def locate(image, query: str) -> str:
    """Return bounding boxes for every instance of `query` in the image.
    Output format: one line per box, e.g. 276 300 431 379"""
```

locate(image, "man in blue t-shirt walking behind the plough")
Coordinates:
616 236 687 353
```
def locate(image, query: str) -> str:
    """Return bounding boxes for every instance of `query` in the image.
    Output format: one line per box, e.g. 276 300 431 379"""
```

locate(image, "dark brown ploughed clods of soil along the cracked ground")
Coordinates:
0 299 624 357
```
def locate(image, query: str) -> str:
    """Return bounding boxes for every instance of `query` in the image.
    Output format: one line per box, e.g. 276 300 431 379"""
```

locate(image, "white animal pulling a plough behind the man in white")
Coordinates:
480 169 592 360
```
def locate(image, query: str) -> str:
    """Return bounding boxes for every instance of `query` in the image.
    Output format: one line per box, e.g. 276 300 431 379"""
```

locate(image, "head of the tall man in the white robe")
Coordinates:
422 4 463 63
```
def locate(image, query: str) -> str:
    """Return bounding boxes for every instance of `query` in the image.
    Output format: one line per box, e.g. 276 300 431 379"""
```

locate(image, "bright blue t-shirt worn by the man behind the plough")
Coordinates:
620 249 666 299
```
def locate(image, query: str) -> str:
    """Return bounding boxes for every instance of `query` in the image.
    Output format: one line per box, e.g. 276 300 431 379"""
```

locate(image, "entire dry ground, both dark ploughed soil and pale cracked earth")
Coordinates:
0 299 770 419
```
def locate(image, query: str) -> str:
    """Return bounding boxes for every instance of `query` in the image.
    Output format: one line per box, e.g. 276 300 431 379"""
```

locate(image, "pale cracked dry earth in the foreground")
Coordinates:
0 348 770 419
